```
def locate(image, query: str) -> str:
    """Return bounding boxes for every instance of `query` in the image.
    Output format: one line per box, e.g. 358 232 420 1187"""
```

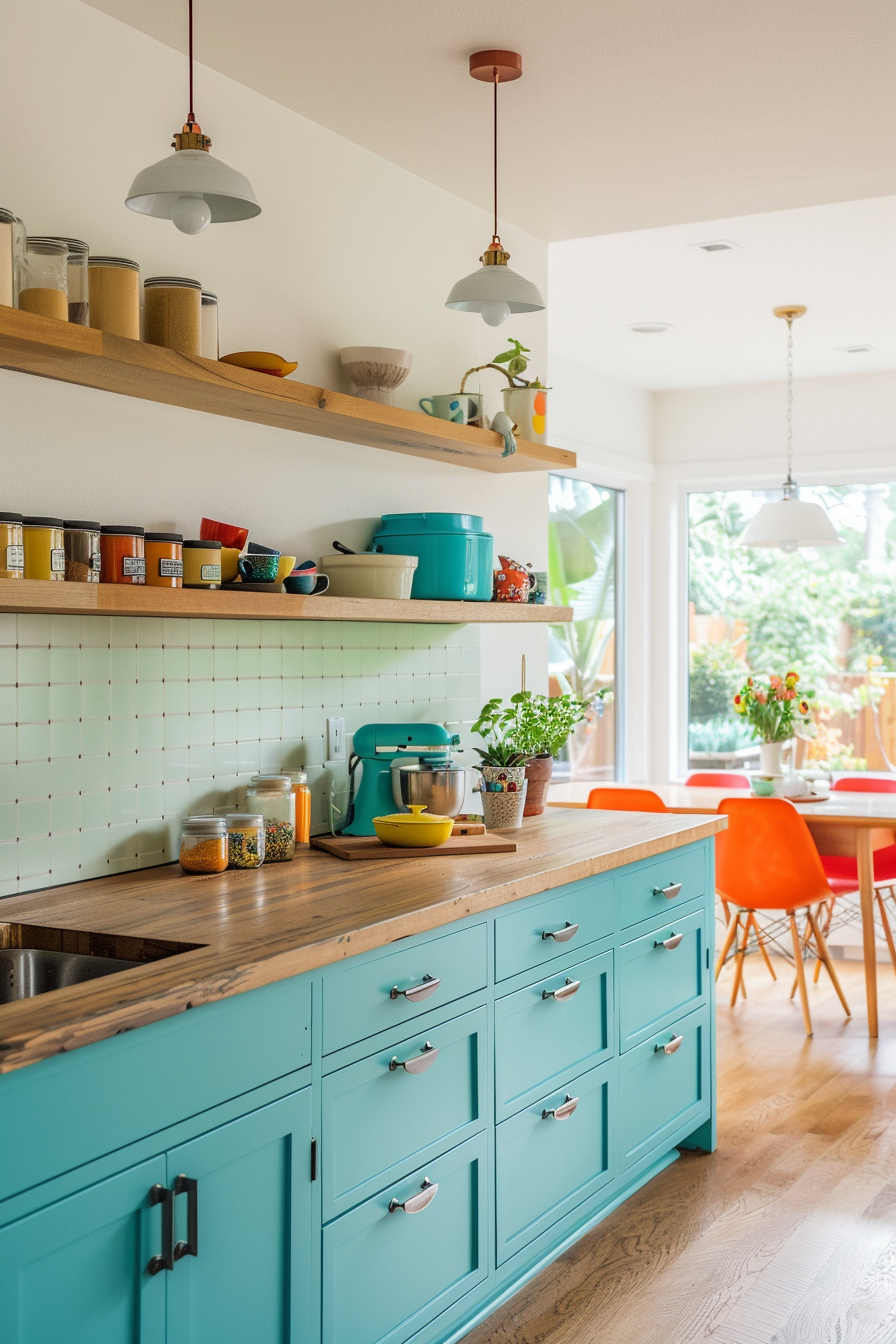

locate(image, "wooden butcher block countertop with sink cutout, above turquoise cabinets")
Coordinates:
0 809 725 1073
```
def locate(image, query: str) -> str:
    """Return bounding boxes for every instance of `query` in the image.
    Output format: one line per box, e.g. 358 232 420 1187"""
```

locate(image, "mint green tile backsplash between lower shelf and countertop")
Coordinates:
0 614 481 895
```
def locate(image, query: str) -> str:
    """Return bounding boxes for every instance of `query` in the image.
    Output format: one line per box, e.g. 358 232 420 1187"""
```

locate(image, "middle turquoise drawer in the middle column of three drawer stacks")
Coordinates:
494 952 613 1120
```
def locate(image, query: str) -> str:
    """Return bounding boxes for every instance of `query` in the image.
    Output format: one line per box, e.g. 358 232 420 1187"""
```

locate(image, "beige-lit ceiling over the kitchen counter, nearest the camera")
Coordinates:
83 0 896 241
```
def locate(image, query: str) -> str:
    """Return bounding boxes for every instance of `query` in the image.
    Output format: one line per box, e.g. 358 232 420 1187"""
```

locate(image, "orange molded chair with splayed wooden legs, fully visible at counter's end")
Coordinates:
716 798 850 1036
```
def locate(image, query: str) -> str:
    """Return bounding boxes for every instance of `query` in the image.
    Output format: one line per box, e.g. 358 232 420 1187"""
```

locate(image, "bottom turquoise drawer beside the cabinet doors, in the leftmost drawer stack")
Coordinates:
322 1134 489 1344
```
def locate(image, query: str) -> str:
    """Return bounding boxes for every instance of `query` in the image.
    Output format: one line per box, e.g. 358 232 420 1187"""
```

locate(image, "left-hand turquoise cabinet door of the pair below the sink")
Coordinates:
0 1157 171 1344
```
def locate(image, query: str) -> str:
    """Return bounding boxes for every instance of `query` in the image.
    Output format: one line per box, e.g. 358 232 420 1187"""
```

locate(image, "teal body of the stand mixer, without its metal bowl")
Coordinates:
341 723 461 836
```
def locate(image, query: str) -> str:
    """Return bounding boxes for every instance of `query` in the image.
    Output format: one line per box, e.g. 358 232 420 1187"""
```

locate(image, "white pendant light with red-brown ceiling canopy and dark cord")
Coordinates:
445 51 544 327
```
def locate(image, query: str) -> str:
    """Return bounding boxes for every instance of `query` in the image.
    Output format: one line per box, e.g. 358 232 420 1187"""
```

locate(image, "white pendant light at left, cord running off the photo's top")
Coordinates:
125 0 262 234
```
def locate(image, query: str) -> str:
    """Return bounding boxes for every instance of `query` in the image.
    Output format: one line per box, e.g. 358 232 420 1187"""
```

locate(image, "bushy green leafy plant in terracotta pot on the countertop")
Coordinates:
473 691 588 817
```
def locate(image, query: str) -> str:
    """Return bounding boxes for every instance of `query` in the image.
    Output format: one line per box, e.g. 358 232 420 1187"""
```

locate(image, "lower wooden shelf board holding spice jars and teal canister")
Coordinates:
0 579 572 625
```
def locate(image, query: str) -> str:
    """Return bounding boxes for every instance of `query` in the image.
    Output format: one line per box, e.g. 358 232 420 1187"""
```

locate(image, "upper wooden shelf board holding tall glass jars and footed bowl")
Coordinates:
0 306 576 473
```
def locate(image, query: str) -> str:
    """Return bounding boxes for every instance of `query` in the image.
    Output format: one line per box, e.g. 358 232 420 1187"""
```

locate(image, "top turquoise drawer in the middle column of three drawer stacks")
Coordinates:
494 878 615 980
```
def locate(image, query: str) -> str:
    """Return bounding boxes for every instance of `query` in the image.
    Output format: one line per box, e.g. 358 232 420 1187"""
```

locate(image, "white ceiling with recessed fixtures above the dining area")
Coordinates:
548 196 896 390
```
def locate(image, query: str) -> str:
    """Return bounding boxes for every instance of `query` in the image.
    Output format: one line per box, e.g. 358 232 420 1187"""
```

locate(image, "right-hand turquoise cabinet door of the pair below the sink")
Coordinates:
165 1087 313 1344
